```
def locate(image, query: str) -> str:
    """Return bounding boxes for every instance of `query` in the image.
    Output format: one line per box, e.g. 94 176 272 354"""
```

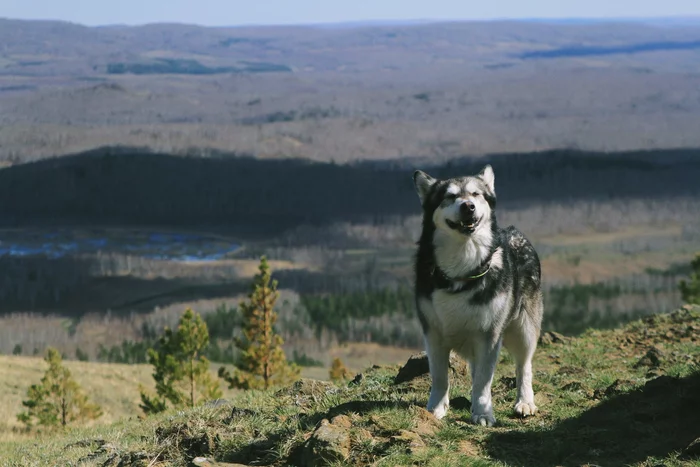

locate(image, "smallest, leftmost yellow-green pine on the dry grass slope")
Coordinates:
17 348 102 427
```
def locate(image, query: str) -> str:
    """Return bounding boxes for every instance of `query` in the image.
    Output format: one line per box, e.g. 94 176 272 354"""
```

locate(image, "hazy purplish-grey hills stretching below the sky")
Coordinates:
0 20 700 164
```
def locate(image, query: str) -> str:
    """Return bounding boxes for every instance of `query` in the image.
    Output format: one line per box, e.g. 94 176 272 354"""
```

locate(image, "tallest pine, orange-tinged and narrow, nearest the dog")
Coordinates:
219 256 300 389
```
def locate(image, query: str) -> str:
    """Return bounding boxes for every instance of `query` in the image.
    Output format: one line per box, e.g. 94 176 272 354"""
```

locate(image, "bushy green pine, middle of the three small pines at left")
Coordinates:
141 308 221 414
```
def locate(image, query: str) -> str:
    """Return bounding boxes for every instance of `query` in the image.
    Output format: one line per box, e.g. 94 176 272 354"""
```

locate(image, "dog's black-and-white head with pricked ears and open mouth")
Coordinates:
413 165 496 236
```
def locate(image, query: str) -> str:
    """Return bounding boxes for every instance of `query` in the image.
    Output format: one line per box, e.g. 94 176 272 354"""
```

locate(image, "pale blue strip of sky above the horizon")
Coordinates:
0 0 700 26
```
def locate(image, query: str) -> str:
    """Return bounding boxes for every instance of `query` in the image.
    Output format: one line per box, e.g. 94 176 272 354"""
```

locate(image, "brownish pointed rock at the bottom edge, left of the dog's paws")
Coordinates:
302 419 350 467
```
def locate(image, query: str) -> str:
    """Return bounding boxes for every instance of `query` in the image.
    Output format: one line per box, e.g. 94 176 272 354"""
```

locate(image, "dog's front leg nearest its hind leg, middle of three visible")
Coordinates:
470 339 501 426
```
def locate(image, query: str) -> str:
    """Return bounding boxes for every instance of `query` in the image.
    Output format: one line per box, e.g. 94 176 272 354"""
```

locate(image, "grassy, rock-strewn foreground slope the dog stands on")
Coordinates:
0 307 700 467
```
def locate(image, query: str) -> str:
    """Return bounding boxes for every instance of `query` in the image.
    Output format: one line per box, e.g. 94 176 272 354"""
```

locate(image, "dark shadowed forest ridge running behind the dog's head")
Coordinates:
0 148 700 237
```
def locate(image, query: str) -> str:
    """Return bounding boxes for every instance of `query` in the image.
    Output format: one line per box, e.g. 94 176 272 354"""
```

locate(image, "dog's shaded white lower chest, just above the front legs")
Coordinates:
418 290 509 339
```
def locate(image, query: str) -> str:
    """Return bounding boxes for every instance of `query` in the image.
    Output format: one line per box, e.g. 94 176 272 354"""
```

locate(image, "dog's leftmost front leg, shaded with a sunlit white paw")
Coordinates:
425 332 450 420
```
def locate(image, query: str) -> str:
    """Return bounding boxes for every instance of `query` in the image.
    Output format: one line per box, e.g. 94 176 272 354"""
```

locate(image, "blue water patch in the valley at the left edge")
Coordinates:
0 229 239 261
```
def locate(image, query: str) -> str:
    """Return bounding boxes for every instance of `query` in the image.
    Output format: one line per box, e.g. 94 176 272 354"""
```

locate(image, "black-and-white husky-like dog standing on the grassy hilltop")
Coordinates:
413 165 543 426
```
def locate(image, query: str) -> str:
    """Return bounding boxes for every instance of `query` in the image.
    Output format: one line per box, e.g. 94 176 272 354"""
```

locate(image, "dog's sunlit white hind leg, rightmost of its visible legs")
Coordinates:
503 300 542 417
